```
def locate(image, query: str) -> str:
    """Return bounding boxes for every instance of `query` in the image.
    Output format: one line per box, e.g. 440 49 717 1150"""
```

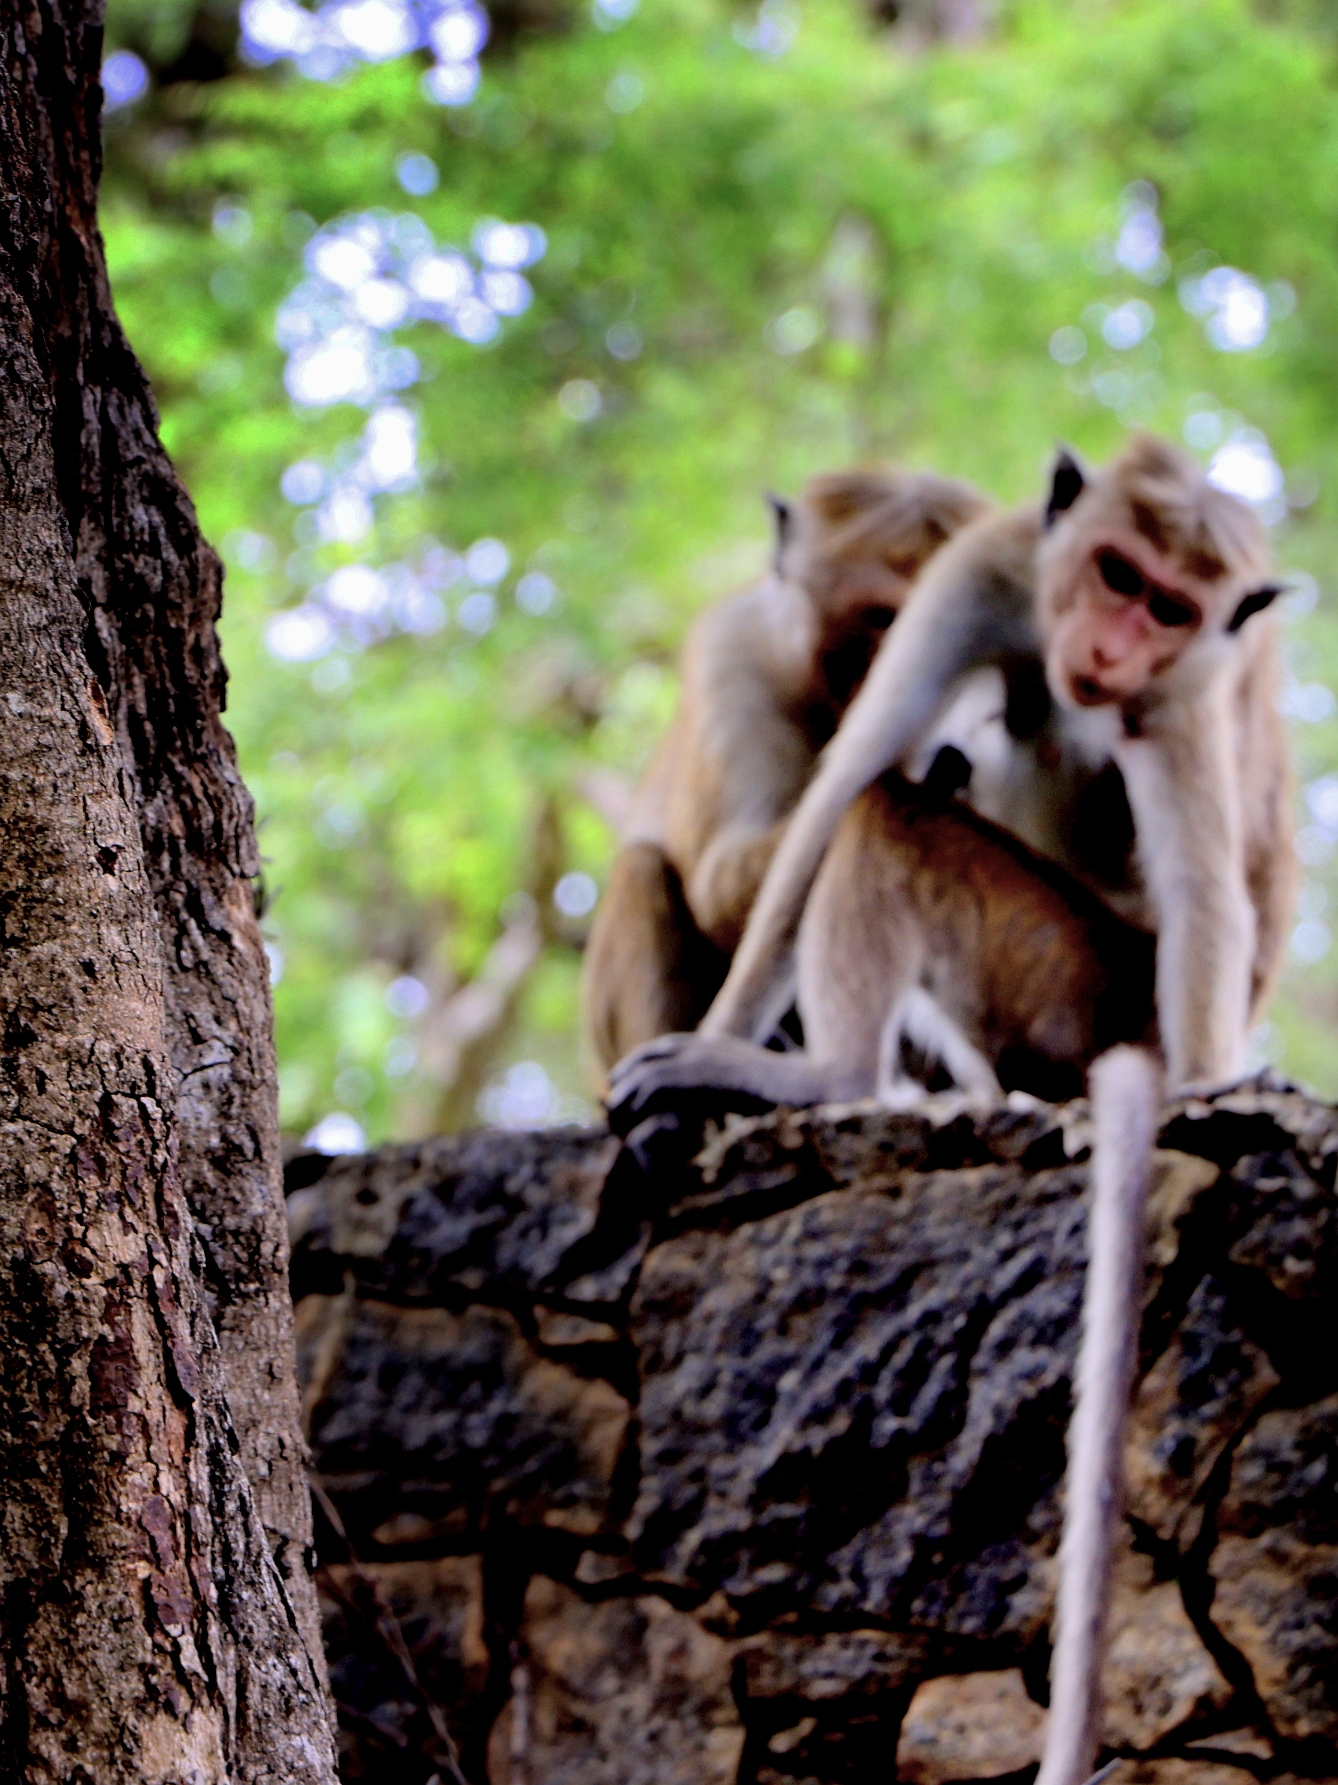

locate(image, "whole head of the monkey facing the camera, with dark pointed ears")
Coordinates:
1038 434 1277 716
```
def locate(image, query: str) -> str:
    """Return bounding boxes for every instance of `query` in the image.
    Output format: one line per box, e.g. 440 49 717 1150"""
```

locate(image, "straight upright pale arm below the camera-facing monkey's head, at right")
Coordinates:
1117 682 1256 1085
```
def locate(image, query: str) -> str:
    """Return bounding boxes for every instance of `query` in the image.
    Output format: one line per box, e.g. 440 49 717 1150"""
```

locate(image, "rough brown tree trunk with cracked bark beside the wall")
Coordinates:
0 0 334 1785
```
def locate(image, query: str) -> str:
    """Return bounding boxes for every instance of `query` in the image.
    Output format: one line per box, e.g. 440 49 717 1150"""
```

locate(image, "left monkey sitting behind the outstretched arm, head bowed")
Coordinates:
583 469 987 1066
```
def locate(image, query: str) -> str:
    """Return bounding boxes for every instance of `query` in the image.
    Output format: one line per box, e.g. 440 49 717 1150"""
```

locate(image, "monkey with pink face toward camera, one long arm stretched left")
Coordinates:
619 436 1295 1094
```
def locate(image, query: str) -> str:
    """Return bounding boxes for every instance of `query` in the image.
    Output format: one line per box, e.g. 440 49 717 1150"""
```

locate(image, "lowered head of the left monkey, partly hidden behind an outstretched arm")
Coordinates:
771 468 988 705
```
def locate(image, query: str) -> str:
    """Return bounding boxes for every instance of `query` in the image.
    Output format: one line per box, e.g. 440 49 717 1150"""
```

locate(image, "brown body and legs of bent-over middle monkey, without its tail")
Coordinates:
608 746 1156 1133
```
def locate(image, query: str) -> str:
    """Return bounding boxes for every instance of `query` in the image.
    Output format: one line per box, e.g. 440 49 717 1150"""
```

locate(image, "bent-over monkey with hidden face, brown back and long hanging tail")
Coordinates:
610 785 1161 1785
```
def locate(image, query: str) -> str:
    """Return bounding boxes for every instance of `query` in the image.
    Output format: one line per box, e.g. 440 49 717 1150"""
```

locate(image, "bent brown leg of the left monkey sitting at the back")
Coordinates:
582 843 730 1069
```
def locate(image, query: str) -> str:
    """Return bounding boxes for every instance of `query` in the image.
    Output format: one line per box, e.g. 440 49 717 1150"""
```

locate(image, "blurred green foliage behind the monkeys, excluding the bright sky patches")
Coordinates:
103 0 1338 1135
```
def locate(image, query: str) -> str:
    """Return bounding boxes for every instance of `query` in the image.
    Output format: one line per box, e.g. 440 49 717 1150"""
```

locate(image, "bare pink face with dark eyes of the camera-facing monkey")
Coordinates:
1045 534 1224 707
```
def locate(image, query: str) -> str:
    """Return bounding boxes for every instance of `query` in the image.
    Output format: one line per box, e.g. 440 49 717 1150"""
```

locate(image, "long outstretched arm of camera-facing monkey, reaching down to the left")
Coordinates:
701 511 1038 1039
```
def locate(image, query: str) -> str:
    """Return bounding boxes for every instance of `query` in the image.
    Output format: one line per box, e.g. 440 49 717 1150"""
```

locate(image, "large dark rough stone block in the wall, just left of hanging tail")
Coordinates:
630 1166 1081 1635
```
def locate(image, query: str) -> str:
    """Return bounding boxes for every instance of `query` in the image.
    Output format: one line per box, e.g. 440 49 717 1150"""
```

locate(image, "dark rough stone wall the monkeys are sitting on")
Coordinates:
289 1082 1338 1785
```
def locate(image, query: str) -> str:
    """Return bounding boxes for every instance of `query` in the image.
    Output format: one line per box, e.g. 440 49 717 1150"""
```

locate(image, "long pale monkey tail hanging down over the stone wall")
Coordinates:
1037 1048 1163 1785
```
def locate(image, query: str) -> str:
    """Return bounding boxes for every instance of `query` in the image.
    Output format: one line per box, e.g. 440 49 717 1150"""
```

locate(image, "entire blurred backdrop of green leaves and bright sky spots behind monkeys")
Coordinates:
102 0 1338 1150
